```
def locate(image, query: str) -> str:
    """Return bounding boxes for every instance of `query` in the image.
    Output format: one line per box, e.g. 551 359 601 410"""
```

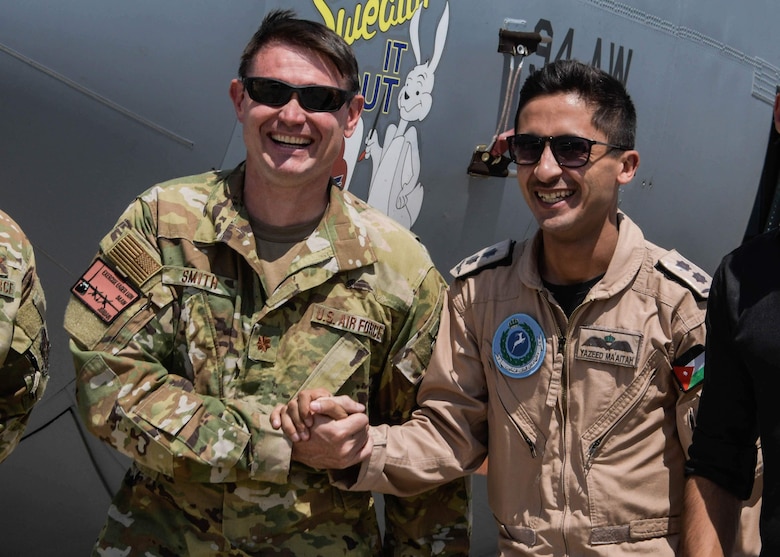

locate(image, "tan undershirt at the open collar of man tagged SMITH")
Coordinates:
249 211 322 295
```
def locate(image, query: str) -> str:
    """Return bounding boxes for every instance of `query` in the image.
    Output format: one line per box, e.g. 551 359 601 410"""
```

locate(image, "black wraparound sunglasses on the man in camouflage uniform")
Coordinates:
241 77 354 112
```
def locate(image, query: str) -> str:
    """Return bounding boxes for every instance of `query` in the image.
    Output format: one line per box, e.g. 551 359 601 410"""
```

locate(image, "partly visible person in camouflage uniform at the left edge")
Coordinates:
0 211 49 462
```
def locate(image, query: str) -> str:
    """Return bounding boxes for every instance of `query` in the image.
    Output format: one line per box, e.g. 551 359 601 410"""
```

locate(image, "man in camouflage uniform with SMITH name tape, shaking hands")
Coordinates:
65 11 469 556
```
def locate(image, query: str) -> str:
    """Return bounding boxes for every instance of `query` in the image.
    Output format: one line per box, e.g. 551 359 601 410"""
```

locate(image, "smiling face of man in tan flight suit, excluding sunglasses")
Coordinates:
515 93 639 245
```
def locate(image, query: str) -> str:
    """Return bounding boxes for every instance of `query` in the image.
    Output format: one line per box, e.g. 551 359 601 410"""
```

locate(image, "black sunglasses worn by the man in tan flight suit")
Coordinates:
507 133 631 168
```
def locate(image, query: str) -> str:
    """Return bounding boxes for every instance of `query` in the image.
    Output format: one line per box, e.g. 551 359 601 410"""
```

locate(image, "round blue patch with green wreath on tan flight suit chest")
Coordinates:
493 313 547 379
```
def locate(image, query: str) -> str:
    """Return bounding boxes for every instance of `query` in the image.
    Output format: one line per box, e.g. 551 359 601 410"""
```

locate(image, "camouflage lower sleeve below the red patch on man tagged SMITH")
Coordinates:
70 320 290 483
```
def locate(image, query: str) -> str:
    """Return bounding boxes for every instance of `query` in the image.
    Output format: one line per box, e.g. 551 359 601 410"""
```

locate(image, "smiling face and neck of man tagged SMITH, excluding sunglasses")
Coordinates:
230 43 363 193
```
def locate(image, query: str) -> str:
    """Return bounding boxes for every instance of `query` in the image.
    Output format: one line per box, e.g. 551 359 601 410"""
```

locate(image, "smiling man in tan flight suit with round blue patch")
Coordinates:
272 61 755 557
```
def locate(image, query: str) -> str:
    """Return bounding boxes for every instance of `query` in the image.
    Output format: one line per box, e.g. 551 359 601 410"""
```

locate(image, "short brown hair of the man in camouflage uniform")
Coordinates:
238 10 360 93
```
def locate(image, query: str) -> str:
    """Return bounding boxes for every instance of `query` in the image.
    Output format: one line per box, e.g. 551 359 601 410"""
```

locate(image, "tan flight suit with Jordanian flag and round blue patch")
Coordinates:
335 213 756 557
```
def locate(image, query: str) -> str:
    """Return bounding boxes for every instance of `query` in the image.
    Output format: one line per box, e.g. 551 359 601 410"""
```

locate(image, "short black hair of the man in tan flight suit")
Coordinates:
515 60 636 149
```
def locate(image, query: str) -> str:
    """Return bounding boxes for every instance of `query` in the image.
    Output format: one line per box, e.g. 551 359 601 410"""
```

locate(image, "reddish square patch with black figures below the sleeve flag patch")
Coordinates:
70 259 139 323
